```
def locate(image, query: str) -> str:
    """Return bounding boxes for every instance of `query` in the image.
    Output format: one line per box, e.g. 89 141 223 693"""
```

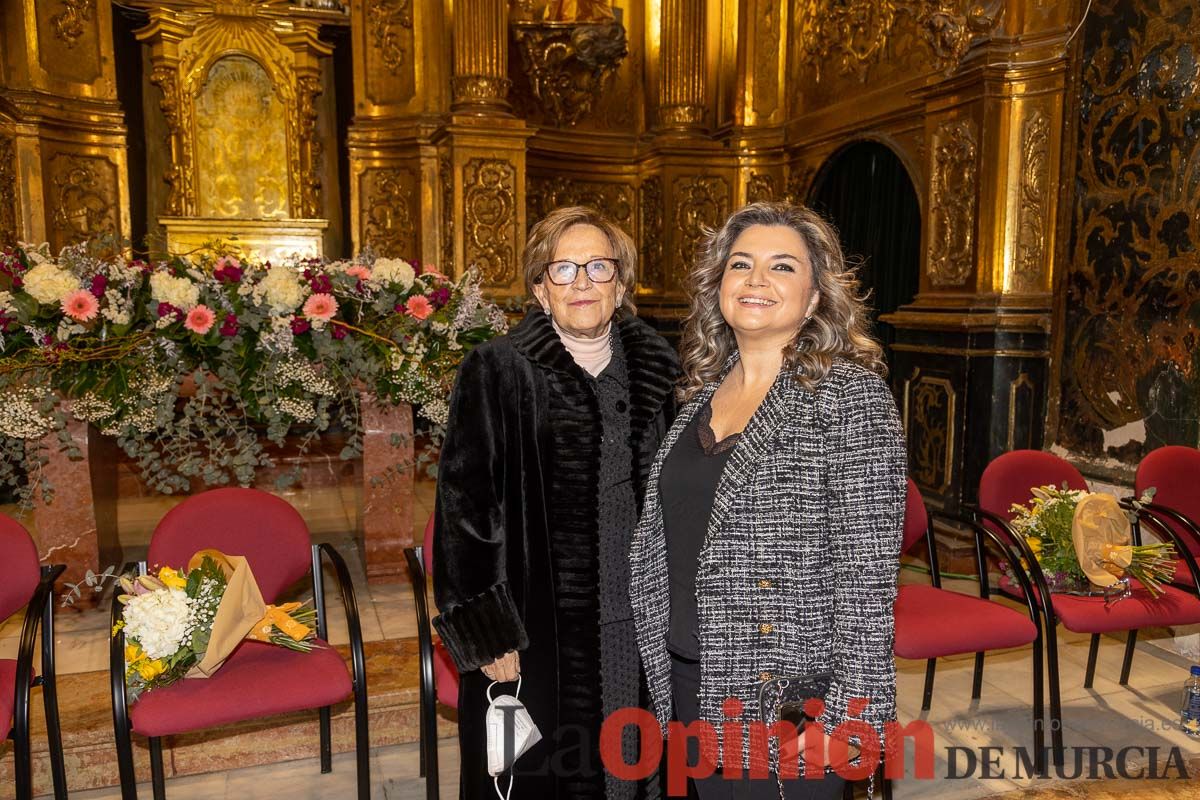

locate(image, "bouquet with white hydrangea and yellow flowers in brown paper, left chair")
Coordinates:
113 549 317 699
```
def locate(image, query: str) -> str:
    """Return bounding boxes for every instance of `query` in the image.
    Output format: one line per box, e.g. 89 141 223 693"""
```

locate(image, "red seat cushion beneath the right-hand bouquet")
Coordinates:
1054 582 1200 633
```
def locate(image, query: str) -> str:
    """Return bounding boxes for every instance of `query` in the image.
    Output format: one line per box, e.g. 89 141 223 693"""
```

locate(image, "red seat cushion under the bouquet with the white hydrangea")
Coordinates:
130 639 353 736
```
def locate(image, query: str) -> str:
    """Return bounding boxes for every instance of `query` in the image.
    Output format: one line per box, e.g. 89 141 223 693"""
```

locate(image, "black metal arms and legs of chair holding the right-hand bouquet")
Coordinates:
962 504 1200 766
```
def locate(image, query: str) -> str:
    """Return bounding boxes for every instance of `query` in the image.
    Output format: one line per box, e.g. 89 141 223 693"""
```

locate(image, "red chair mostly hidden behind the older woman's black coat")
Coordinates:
404 515 458 800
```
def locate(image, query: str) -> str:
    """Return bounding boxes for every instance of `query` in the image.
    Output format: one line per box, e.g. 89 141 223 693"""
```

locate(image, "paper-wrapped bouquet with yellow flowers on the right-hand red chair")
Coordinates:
1012 486 1175 600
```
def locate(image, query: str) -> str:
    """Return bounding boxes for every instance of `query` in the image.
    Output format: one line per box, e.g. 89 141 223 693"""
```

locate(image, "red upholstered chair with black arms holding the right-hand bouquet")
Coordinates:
967 450 1200 764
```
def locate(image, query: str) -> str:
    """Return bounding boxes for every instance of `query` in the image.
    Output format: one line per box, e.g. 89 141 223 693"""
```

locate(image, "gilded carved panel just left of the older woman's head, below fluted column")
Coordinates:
462 158 516 287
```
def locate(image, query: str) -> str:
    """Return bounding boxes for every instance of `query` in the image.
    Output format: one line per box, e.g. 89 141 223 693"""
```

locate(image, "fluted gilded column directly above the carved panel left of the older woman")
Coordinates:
451 0 511 114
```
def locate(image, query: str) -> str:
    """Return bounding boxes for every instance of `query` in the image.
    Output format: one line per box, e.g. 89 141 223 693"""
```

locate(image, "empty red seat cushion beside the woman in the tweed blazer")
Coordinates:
894 585 1038 658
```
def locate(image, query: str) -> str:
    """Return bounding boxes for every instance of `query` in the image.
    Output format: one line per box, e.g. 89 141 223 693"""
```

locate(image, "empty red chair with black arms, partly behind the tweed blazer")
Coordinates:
894 479 1045 769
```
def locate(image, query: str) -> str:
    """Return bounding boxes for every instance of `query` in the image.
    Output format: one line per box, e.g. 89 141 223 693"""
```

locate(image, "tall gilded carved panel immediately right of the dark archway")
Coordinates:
928 120 978 287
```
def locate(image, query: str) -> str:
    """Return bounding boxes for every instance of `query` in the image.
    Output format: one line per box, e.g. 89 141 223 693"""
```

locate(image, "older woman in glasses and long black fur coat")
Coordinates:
433 207 679 800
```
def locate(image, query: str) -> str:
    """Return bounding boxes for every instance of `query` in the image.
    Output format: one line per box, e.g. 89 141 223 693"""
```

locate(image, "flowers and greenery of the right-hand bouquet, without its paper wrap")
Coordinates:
1010 485 1175 597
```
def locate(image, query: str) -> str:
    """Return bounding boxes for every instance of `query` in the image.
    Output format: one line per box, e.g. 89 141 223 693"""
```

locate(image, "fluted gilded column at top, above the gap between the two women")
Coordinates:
658 0 706 128
